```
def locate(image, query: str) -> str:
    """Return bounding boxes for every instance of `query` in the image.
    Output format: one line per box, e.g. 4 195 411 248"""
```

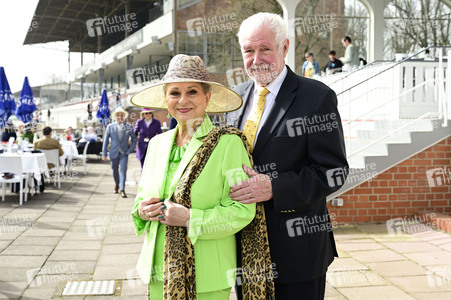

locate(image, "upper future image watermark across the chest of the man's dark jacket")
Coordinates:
286 113 339 137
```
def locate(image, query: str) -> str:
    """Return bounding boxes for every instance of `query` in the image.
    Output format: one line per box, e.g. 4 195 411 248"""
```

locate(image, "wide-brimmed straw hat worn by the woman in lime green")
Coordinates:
130 54 243 113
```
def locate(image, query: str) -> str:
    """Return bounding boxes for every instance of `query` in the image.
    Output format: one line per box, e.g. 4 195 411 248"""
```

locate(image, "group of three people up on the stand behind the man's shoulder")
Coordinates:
301 36 366 78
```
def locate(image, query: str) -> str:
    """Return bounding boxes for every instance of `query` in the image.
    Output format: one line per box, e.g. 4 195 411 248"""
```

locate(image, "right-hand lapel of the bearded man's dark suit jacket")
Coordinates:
252 66 297 156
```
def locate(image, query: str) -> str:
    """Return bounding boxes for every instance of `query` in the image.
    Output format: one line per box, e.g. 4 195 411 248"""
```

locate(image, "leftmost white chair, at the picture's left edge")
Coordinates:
0 156 28 205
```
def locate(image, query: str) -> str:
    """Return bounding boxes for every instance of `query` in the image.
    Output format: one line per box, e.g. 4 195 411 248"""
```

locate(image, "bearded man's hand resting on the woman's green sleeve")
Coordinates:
229 165 272 204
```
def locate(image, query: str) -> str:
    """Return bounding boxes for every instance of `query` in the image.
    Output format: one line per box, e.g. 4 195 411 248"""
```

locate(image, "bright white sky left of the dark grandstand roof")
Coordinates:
0 0 92 92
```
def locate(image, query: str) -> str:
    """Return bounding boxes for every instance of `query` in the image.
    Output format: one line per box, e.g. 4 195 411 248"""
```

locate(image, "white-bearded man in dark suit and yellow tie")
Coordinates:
230 13 348 300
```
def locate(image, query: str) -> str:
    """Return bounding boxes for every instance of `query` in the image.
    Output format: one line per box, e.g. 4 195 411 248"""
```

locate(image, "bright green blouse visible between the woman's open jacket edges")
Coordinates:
150 143 189 282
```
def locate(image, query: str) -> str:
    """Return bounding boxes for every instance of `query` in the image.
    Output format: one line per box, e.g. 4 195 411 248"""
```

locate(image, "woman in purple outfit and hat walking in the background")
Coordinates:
134 108 161 169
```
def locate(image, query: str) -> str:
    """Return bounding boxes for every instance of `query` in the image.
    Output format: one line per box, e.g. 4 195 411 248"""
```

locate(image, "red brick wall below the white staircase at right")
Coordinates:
328 137 451 223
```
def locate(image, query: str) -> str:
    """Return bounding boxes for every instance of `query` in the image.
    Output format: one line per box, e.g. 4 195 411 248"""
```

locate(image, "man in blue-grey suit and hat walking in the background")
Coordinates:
102 107 136 198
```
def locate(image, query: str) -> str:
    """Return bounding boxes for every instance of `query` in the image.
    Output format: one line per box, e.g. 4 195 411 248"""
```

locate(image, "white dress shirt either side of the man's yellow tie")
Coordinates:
240 66 288 147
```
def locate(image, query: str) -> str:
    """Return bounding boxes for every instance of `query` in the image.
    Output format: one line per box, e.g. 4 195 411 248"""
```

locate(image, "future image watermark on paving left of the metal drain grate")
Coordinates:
25 263 78 288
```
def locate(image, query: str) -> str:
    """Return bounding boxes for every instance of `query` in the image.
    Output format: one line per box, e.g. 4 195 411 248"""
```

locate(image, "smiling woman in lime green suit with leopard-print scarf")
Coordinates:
131 55 273 300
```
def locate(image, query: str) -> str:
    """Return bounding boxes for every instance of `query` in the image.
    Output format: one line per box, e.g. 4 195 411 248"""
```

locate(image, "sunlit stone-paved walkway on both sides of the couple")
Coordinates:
0 155 451 300
